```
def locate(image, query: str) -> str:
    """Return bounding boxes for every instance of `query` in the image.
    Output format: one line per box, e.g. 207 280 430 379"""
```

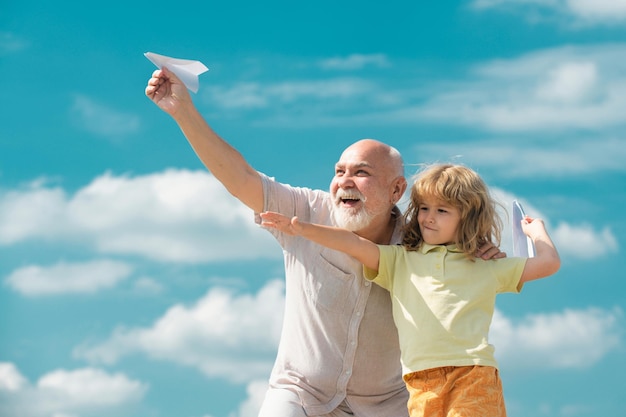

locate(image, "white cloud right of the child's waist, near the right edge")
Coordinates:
490 308 624 370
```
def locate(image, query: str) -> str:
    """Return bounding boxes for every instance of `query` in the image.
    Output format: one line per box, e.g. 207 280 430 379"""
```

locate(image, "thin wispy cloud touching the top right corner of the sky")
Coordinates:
471 0 626 28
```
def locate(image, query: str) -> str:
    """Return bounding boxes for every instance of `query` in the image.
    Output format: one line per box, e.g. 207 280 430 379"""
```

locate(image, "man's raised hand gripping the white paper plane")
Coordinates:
146 67 191 116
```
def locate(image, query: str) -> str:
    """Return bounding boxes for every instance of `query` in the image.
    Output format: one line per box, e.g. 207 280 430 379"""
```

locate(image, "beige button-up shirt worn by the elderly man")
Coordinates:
257 175 408 417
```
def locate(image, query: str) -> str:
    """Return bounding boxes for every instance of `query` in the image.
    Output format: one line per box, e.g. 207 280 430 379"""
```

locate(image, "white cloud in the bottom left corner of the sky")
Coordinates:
0 363 148 417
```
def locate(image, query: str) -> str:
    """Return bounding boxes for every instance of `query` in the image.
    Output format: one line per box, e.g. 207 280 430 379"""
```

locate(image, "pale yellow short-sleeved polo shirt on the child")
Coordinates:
364 240 526 375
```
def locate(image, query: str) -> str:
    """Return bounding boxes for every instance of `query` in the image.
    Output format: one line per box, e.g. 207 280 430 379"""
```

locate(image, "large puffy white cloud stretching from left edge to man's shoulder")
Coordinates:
0 169 280 262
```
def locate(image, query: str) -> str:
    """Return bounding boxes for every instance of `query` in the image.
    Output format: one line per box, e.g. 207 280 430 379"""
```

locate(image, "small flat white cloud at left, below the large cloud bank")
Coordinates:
5 259 132 297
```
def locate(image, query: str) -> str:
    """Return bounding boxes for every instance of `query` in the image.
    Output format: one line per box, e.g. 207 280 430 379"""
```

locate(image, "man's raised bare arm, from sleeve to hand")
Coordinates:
146 68 263 212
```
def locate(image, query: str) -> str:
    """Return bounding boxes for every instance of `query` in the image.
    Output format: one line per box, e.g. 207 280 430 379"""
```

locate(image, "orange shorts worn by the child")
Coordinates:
404 366 506 417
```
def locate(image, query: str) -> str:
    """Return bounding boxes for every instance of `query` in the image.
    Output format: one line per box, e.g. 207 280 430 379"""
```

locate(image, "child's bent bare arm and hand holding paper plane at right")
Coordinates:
520 216 561 283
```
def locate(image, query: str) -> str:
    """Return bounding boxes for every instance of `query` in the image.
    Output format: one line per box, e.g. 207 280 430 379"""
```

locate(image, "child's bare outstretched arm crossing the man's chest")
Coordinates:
261 211 380 271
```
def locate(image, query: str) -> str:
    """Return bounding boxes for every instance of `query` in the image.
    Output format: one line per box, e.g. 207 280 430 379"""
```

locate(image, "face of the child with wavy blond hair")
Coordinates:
417 198 461 245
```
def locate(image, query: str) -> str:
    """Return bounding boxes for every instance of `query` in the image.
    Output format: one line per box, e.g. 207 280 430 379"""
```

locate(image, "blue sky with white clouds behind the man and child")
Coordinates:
0 0 626 417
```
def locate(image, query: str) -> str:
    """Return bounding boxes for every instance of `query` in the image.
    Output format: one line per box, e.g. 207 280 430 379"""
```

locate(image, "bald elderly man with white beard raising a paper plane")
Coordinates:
146 68 503 417
